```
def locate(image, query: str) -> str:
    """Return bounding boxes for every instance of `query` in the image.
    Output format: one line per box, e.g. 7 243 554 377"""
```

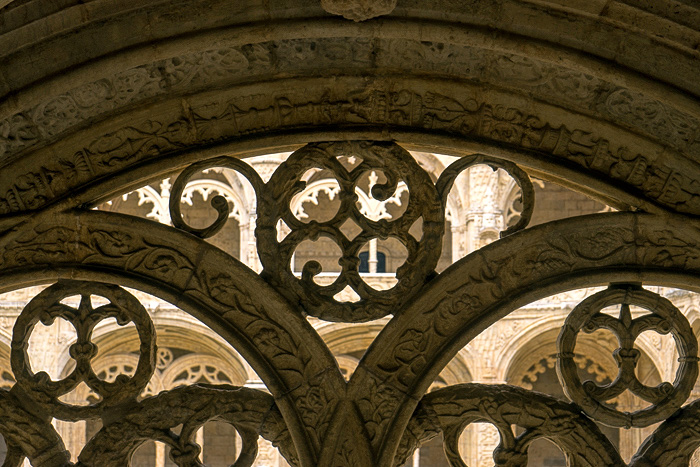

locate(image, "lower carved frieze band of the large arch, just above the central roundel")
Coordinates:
0 84 688 218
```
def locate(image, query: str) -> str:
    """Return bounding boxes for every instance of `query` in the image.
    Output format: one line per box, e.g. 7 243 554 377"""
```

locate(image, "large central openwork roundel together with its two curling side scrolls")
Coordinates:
170 141 534 323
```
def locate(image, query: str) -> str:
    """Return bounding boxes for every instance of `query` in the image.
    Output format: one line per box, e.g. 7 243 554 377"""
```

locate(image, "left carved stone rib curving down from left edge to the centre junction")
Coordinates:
3 211 342 467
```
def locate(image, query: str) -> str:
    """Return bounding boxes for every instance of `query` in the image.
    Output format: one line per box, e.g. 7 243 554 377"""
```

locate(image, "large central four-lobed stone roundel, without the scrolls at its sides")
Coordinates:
256 141 444 322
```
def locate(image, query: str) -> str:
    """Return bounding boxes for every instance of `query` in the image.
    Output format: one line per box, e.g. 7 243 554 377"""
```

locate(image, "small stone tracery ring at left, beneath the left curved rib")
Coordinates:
10 281 156 421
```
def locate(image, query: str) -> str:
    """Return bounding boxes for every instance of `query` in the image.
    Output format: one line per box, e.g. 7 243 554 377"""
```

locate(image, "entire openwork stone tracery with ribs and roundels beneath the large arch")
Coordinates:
0 141 700 467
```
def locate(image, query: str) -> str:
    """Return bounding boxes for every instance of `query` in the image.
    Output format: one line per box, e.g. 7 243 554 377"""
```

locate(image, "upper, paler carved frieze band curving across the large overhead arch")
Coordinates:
0 36 700 163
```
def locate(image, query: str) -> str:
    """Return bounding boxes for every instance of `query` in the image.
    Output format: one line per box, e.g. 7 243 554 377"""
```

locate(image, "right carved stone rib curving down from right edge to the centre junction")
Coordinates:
356 213 700 467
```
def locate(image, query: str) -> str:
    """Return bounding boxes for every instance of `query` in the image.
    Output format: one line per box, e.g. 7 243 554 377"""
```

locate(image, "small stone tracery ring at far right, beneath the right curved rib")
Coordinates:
556 286 698 428
